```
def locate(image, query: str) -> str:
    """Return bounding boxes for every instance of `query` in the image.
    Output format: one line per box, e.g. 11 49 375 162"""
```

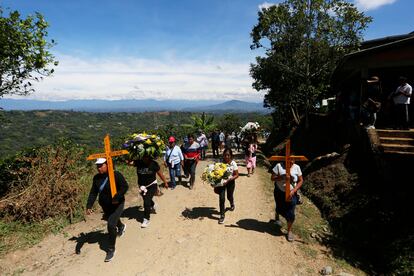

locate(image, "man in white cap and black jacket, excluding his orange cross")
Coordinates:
86 158 128 262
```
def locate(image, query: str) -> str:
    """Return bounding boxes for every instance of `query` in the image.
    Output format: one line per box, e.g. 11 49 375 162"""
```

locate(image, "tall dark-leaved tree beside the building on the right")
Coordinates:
250 0 372 128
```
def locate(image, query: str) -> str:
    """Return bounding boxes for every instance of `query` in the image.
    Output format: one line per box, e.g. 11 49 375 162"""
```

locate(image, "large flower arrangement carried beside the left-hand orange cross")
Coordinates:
122 132 165 160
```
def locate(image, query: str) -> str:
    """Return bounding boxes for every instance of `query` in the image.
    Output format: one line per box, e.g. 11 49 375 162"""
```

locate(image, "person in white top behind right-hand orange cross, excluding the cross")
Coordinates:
271 160 303 242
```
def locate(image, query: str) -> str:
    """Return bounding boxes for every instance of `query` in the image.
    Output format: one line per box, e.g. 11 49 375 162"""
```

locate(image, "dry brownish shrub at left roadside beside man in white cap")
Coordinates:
0 141 92 222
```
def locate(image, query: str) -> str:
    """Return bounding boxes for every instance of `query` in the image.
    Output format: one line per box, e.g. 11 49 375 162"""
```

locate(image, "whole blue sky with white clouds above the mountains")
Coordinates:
0 0 414 102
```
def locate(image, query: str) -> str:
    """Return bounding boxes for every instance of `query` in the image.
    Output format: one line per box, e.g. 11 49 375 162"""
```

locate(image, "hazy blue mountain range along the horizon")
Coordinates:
0 99 268 113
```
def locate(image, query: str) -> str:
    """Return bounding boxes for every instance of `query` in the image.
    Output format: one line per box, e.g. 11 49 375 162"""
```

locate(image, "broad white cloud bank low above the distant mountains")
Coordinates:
12 55 263 101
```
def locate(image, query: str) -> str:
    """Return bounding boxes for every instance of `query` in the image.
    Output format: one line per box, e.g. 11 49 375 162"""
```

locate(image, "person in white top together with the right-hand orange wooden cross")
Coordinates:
269 140 308 242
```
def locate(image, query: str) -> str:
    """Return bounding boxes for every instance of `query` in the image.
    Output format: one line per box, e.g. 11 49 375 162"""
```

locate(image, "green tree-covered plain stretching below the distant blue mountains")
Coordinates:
0 110 270 158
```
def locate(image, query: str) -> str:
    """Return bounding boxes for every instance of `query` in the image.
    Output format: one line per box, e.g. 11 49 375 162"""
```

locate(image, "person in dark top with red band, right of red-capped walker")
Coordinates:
183 134 200 190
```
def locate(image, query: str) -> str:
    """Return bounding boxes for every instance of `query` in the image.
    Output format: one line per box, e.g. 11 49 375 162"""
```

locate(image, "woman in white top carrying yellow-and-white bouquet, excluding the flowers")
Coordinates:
214 148 239 224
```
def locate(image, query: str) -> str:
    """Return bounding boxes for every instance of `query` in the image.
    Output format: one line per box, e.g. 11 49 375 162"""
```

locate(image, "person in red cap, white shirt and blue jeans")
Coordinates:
164 136 184 190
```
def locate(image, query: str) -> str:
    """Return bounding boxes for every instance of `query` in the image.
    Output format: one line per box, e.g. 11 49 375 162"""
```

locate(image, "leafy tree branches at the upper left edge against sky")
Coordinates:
0 7 57 98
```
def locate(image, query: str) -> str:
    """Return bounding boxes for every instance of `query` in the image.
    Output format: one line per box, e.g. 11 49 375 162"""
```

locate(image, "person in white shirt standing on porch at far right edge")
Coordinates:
388 77 413 129
